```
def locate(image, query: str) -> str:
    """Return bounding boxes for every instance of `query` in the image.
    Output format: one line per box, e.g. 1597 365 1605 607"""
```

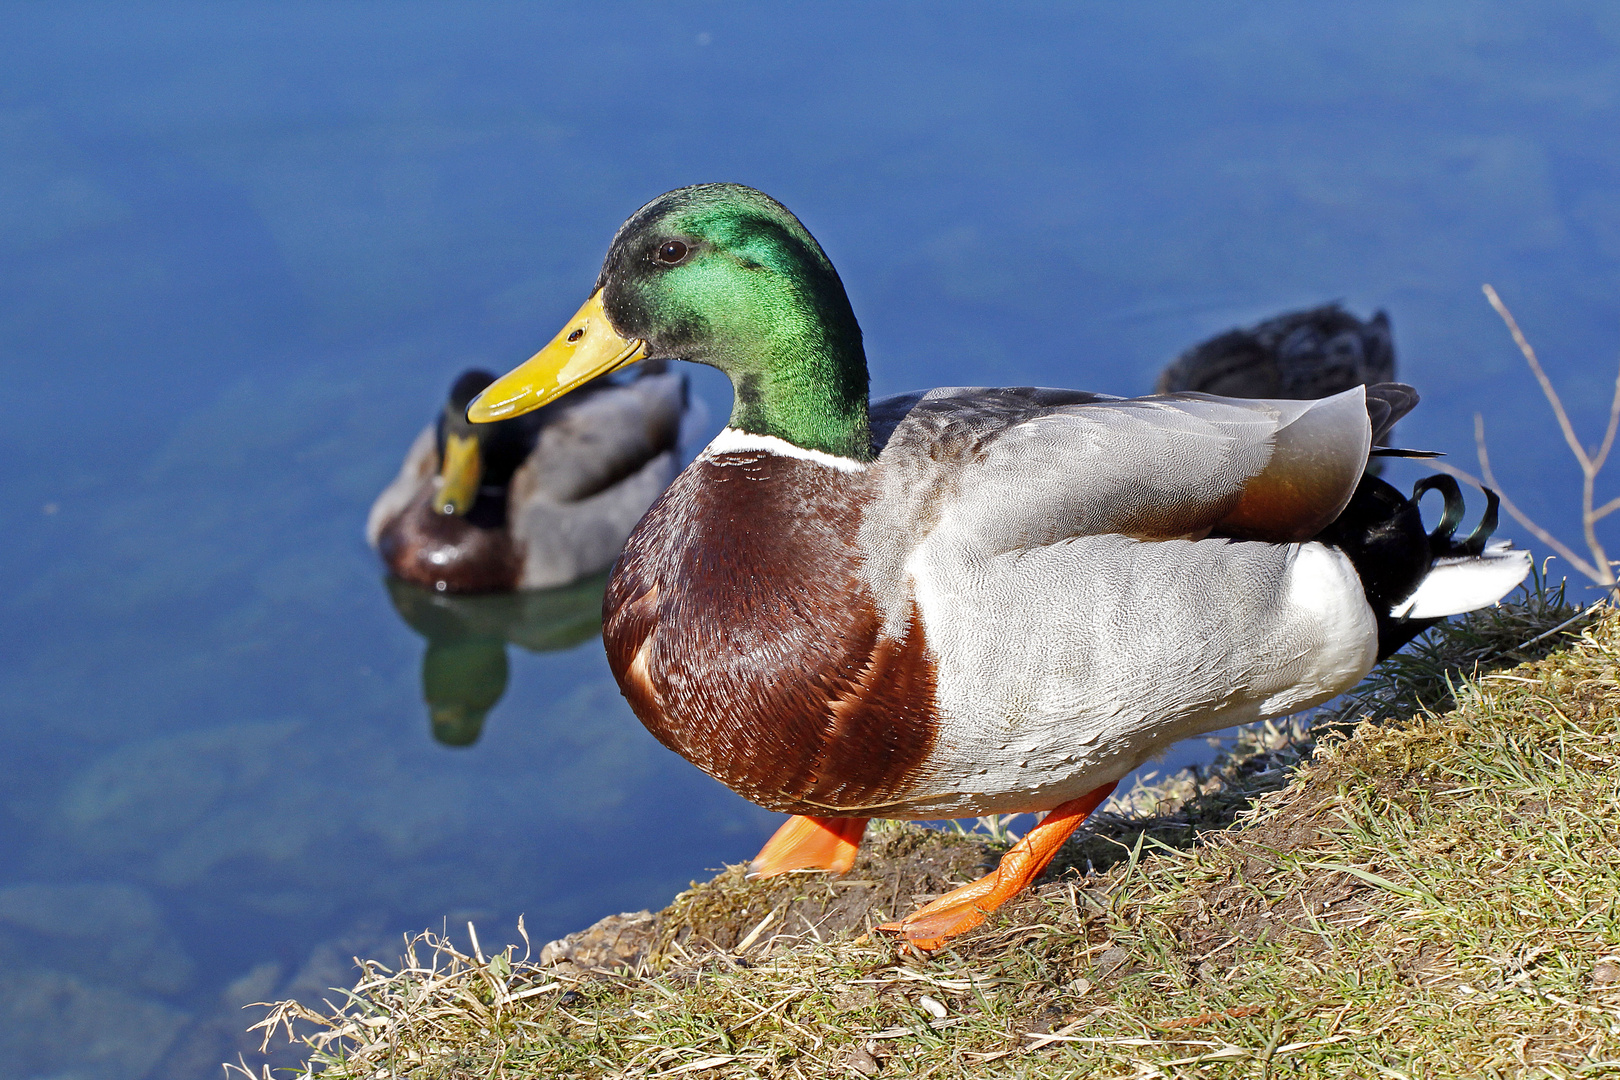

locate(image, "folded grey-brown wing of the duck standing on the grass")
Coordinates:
868 387 1372 555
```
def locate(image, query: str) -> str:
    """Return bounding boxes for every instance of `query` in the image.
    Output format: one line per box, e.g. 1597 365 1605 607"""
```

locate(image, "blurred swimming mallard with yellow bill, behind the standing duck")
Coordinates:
366 363 687 593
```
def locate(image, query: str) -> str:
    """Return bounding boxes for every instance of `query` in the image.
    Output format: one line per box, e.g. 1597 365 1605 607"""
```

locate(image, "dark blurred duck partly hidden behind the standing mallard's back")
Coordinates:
1153 304 1395 400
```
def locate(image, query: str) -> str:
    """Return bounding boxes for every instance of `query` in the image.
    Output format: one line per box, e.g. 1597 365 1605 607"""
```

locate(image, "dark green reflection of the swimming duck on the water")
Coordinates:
386 572 608 746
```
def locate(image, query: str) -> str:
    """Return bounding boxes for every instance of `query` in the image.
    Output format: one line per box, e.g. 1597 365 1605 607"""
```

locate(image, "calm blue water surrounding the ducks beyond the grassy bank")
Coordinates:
0 0 1620 1080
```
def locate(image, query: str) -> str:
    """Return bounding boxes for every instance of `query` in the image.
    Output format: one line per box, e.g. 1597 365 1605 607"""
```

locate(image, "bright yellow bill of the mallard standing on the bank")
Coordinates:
467 290 646 424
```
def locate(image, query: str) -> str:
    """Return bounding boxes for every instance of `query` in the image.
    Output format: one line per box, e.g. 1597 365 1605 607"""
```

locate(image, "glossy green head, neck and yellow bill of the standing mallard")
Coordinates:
468 185 872 460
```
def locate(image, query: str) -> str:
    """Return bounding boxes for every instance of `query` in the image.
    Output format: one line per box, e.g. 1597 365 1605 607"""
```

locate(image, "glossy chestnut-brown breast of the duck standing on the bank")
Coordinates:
603 452 938 816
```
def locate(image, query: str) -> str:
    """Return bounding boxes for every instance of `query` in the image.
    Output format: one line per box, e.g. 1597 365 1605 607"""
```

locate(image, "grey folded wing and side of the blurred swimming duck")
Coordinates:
509 372 687 589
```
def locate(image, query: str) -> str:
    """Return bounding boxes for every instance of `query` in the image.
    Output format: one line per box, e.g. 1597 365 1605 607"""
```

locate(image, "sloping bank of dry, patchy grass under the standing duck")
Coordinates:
243 594 1620 1078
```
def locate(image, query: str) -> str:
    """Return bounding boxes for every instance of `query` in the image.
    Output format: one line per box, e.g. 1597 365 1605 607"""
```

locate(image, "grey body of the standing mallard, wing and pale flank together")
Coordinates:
862 387 1405 816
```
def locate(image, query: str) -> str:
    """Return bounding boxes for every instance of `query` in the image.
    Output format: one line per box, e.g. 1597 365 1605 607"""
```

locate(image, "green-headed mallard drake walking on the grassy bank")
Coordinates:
468 185 1529 947
